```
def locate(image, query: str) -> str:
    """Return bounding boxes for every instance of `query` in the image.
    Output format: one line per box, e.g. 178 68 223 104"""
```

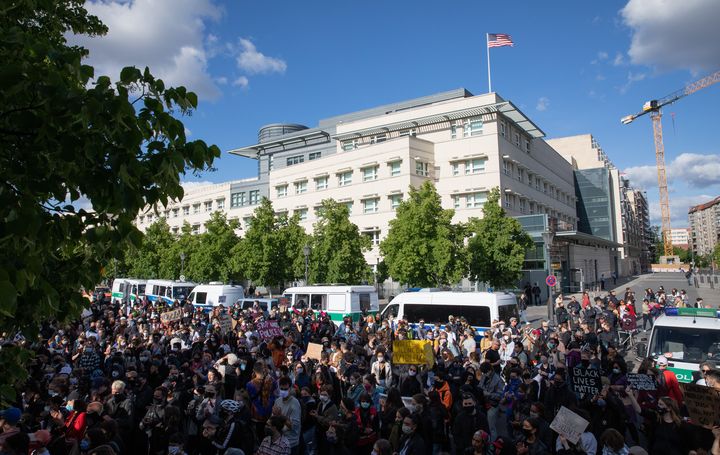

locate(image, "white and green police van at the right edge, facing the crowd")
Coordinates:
637 307 720 382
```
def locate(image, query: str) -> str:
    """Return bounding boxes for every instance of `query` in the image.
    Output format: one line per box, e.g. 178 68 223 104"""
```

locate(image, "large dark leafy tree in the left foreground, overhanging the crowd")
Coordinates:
0 0 220 399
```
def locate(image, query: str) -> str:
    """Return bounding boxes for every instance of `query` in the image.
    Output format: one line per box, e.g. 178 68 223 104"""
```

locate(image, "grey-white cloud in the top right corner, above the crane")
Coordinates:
620 0 720 71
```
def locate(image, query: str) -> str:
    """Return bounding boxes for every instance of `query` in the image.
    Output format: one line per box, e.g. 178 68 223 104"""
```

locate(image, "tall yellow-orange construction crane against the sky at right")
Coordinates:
620 71 720 256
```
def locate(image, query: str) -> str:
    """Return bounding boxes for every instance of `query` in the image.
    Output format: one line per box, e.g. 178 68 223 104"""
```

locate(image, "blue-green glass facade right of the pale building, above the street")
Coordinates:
575 167 615 241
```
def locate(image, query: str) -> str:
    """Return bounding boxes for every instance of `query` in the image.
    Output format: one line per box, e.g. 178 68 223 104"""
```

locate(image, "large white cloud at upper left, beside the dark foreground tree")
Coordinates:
69 0 222 99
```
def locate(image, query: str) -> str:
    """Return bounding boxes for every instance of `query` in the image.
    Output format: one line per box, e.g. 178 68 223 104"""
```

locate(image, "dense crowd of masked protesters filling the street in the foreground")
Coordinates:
0 288 720 455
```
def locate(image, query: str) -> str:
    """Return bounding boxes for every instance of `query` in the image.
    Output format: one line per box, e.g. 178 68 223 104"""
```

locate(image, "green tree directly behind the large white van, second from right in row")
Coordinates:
380 181 466 287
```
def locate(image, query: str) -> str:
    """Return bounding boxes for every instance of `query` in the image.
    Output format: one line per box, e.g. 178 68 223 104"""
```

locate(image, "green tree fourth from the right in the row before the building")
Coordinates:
230 198 308 287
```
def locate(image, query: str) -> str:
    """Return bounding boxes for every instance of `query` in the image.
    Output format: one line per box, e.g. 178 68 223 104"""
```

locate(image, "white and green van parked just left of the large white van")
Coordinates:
283 285 379 325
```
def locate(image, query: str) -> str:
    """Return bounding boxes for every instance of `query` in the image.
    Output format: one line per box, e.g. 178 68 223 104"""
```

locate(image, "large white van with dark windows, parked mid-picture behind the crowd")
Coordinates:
381 289 518 335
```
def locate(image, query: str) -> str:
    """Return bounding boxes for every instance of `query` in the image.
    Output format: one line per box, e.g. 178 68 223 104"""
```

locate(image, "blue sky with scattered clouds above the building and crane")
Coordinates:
73 0 720 226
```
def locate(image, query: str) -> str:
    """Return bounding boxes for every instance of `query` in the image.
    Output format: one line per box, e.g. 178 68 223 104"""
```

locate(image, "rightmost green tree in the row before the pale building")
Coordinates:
467 187 534 289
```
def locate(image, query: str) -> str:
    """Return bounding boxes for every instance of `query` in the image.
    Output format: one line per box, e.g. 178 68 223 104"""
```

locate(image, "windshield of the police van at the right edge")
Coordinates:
650 326 720 363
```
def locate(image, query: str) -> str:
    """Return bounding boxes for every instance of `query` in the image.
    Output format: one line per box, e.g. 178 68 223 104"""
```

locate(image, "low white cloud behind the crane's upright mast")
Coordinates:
623 153 720 190
